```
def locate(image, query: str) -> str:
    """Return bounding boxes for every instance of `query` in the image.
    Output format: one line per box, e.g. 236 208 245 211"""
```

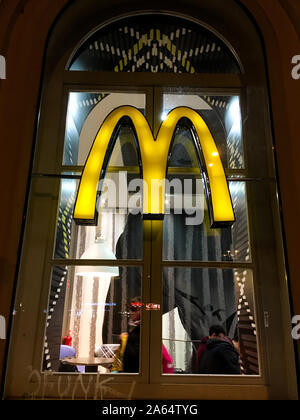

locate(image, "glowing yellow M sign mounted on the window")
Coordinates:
74 106 235 227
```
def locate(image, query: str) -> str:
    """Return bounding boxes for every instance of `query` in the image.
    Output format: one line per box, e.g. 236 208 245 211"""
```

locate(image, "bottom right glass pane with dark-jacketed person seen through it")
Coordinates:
162 268 259 375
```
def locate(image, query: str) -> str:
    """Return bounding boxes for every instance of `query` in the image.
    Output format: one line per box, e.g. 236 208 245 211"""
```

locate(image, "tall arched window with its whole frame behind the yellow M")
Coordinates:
4 0 298 399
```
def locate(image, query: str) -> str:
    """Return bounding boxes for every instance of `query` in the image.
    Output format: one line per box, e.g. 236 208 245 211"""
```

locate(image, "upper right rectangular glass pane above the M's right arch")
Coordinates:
162 92 244 169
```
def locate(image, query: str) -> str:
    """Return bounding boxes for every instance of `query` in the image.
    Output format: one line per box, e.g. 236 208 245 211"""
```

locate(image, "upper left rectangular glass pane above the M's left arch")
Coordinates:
63 92 146 166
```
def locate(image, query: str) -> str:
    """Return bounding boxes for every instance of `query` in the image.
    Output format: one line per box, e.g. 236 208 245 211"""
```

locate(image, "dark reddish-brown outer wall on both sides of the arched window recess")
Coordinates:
0 0 300 396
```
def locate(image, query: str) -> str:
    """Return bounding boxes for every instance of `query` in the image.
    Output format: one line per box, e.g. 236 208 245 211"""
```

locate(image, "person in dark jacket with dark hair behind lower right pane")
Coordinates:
198 327 241 375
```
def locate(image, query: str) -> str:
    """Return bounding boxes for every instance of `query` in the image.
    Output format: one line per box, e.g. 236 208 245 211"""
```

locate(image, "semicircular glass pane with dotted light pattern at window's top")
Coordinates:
70 14 240 74
